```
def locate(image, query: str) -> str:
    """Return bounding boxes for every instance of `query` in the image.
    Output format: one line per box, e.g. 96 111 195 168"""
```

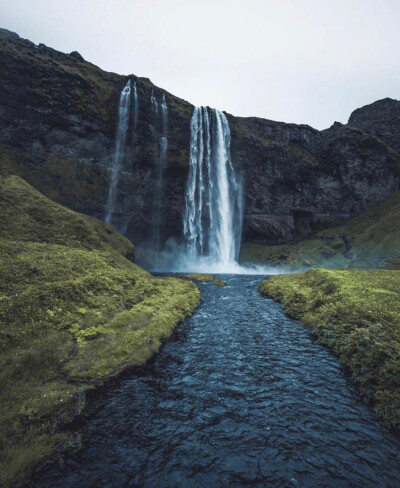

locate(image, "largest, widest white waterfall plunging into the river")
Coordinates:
183 107 243 271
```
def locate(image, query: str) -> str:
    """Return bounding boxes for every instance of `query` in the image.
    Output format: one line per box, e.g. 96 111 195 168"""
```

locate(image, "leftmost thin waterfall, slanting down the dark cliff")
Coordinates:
105 80 131 224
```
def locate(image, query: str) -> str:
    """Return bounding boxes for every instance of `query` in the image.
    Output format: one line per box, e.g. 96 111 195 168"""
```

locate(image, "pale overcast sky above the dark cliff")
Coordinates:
0 0 400 129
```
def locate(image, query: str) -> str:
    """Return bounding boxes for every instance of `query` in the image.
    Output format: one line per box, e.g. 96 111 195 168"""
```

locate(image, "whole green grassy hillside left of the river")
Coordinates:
0 176 200 486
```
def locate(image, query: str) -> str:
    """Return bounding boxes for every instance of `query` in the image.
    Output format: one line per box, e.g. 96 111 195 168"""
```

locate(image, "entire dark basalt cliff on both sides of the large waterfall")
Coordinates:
0 30 400 243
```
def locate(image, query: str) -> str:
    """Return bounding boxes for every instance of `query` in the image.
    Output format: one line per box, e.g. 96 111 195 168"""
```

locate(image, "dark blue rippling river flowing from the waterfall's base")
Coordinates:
33 276 400 488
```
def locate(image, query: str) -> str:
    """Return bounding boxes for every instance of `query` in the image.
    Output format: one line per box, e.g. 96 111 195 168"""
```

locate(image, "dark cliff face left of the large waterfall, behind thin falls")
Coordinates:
0 30 193 244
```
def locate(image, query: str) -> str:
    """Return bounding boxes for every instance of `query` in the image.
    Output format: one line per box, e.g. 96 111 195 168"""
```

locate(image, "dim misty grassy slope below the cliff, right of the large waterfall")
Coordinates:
241 192 400 269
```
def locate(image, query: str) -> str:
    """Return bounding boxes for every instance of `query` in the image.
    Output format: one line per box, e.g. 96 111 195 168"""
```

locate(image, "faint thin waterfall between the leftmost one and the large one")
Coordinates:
150 90 168 254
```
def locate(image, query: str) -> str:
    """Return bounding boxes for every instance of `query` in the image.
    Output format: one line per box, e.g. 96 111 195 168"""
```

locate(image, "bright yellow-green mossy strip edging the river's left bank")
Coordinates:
65 278 199 379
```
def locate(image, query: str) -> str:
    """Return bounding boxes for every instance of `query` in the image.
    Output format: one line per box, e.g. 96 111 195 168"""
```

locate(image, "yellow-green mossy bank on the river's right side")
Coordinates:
259 269 400 429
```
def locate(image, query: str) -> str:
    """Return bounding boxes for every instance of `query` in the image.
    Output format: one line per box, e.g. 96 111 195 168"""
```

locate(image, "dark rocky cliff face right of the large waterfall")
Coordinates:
230 115 400 244
